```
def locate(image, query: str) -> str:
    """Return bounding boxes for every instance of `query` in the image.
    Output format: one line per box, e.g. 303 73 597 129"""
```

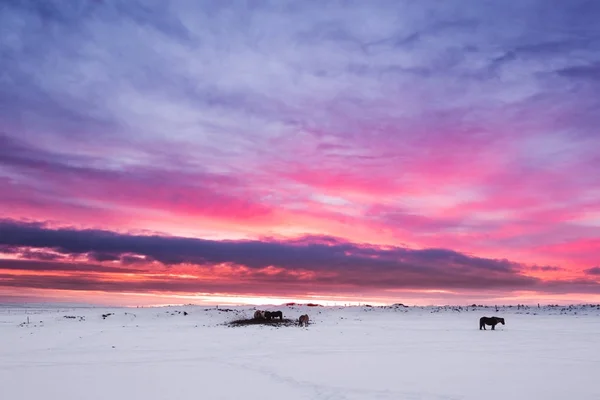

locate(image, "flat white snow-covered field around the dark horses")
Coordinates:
0 306 600 400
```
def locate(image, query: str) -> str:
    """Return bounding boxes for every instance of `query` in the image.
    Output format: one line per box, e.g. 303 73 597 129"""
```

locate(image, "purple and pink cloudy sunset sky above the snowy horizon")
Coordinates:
0 0 600 306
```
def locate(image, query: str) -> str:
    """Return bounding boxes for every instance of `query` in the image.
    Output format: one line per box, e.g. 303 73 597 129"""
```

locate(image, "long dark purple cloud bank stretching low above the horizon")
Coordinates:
0 217 595 292
